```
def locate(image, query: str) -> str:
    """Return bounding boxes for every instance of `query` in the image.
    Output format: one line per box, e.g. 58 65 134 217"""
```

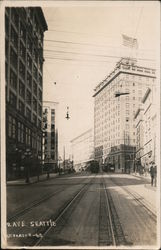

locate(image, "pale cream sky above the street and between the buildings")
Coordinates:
43 1 160 158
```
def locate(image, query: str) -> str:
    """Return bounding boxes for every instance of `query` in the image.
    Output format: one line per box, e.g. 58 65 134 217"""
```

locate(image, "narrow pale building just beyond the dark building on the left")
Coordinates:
42 102 58 171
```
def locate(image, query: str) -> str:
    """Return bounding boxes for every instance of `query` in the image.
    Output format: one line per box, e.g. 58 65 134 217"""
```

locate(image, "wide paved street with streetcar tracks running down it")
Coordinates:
7 172 157 246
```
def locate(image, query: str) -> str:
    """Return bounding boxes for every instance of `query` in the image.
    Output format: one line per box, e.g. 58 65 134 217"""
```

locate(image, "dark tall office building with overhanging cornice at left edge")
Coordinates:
5 7 47 179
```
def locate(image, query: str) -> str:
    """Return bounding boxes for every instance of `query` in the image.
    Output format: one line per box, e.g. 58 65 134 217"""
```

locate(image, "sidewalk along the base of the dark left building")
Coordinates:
7 173 59 186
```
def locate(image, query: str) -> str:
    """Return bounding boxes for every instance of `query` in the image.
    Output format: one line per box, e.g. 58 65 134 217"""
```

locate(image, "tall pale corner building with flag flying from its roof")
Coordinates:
94 58 156 172
